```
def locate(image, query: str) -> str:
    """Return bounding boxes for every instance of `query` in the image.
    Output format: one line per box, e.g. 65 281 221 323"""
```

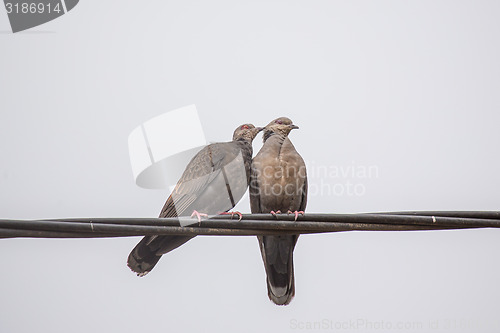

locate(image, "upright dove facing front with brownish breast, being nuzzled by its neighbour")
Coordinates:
250 117 307 305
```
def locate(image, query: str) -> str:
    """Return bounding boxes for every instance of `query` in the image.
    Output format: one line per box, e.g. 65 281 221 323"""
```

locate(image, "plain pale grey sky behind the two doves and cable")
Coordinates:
0 0 500 332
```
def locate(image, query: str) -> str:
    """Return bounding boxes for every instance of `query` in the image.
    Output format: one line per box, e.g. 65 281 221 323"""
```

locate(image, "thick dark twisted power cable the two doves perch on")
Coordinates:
0 211 500 238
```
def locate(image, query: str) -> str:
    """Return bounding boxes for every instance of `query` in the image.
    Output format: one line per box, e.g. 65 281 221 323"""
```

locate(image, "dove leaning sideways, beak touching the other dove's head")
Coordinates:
127 124 262 276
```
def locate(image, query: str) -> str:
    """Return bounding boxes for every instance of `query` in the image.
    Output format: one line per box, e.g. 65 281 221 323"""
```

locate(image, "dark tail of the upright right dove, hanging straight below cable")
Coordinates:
259 235 298 305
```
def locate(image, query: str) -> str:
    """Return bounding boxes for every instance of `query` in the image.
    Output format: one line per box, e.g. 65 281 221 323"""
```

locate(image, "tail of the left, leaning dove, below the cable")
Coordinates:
127 236 193 276
